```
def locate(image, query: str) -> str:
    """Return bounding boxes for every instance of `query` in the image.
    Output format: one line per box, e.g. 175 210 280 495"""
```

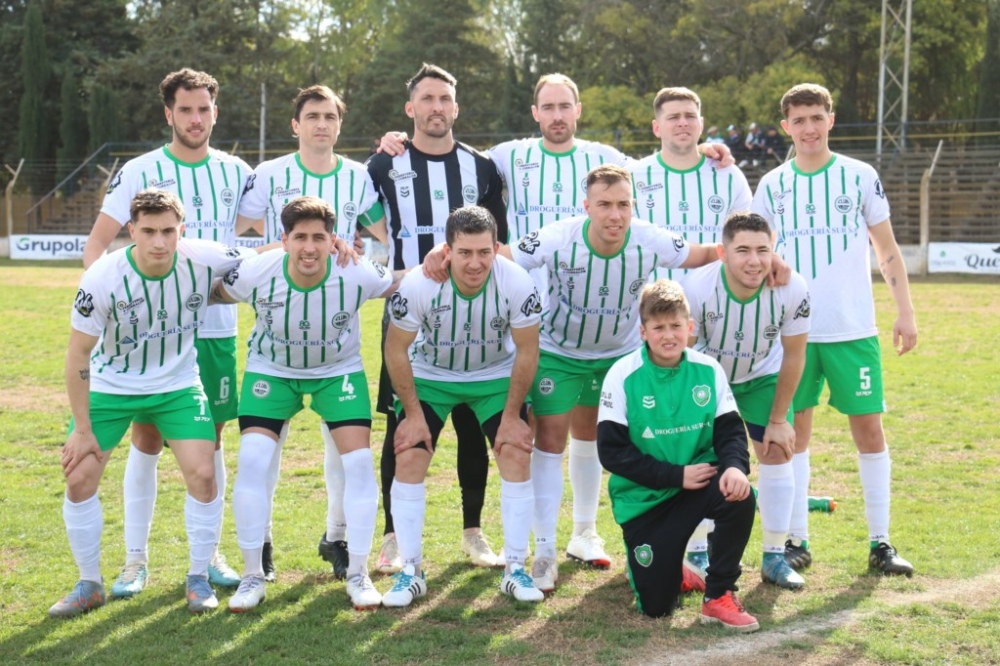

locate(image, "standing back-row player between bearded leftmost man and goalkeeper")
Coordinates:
240 85 388 580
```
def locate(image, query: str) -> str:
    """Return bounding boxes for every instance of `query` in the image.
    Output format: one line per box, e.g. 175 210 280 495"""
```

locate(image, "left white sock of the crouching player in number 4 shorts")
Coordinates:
233 433 277 576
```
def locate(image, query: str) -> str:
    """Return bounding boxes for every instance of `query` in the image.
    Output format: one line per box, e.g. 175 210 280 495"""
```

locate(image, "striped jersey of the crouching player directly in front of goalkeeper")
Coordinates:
389 257 542 382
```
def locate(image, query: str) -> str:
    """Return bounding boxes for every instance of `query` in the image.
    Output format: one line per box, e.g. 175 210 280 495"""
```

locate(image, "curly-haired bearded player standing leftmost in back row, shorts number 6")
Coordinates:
83 69 250 597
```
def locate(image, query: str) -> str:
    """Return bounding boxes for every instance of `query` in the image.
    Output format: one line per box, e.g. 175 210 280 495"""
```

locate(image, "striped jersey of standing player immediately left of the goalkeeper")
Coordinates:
240 152 385 243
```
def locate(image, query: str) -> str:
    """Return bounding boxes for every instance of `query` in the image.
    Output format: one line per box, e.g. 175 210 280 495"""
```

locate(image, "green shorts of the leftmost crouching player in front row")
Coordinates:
69 386 215 451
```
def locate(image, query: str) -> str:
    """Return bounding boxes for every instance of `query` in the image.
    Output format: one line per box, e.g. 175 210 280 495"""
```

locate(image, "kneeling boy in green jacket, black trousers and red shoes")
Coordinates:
597 280 760 632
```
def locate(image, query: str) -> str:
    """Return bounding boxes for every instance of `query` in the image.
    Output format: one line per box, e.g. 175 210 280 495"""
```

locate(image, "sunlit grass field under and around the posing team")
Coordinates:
0 262 1000 666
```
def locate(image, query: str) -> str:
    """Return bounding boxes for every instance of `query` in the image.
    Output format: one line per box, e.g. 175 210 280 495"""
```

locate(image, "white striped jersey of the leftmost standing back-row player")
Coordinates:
101 146 251 338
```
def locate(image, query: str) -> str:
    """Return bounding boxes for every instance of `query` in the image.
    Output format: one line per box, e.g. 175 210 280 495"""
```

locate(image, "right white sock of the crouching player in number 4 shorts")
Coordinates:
342 449 378 577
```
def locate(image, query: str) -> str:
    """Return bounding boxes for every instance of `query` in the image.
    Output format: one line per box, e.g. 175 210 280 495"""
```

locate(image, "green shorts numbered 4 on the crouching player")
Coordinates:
239 370 372 422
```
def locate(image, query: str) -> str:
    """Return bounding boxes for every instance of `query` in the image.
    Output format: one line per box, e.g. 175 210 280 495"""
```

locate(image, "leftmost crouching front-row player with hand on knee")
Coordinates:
49 190 252 617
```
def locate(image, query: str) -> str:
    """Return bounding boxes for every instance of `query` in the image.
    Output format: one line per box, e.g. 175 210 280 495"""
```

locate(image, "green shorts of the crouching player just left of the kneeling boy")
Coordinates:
529 351 621 416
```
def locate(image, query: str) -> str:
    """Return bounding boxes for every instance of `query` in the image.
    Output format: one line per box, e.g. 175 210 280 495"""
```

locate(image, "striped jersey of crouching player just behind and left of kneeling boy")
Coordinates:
510 217 690 359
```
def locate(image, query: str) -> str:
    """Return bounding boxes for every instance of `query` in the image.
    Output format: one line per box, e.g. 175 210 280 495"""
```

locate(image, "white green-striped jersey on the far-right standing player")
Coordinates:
752 153 889 342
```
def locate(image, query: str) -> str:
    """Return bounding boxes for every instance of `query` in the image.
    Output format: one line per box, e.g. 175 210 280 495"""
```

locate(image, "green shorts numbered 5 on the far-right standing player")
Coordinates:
792 336 885 416
